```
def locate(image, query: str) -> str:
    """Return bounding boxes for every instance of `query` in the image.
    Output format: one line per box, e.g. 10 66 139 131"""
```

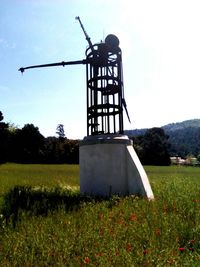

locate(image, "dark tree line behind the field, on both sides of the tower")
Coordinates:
0 111 170 165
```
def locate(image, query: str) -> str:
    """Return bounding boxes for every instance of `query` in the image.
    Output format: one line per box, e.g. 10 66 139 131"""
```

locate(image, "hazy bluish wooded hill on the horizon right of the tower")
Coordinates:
125 119 200 157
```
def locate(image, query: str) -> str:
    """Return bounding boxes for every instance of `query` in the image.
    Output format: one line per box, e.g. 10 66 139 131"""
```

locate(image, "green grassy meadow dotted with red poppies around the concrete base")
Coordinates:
0 164 200 267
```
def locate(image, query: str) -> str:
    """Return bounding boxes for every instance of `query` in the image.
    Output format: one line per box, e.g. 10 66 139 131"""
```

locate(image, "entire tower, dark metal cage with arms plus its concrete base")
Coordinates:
19 17 153 199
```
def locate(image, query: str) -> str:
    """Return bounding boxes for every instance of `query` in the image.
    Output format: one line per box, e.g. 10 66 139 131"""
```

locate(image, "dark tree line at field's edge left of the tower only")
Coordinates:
0 111 79 164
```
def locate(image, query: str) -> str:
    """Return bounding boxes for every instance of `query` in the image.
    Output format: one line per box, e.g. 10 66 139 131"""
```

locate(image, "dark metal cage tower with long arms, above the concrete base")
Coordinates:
19 17 130 135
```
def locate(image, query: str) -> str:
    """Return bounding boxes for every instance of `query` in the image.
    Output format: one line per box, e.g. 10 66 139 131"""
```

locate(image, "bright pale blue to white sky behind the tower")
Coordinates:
0 0 200 138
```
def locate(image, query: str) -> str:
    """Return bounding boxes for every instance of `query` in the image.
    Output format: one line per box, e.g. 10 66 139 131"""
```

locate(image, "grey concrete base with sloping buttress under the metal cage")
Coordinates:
79 135 154 199
